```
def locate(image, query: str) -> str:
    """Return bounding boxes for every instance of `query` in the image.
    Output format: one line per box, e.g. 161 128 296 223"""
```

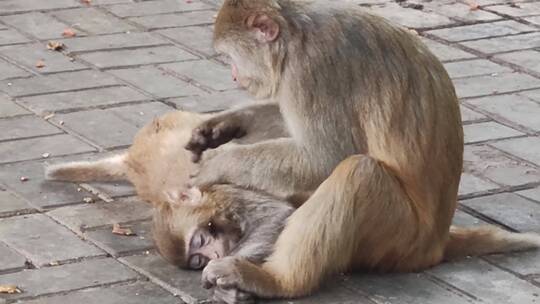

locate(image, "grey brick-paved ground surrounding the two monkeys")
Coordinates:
0 0 540 304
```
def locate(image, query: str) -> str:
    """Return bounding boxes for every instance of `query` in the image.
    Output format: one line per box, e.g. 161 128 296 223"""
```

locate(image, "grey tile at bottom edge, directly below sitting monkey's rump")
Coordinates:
346 274 471 304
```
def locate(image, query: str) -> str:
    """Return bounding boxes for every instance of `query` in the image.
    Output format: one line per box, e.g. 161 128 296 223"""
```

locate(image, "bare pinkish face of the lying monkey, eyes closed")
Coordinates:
186 225 233 270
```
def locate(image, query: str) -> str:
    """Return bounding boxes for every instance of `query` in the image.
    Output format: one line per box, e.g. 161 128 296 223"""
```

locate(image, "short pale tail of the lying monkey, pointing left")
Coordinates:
45 152 128 182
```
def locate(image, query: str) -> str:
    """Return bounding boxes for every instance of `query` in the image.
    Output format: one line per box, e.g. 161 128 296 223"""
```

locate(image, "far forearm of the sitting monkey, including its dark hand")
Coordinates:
186 101 287 162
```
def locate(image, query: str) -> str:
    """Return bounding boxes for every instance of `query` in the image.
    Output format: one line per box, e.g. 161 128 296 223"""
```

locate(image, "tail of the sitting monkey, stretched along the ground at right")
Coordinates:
444 226 540 260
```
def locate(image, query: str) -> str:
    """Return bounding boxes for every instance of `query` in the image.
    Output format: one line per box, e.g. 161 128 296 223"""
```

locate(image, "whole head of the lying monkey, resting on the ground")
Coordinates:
153 185 248 269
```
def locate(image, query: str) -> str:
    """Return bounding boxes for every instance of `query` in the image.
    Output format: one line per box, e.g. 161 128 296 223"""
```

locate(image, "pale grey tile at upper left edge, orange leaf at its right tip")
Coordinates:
0 12 74 40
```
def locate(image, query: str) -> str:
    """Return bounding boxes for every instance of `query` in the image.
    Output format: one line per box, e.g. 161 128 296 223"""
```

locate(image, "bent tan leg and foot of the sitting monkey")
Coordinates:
203 155 418 298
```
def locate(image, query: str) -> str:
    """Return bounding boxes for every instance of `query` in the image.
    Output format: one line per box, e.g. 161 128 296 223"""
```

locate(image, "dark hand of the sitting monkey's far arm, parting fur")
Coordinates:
186 112 246 162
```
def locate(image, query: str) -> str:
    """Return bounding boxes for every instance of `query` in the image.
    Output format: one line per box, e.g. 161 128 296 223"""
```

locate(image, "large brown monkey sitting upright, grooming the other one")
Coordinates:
174 0 540 298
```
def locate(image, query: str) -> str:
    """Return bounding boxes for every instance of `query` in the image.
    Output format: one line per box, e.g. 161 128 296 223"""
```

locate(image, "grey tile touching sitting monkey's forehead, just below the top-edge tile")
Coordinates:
129 11 216 29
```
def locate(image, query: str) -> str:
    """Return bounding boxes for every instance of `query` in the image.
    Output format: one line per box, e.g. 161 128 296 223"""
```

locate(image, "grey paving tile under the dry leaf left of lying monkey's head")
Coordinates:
84 222 154 257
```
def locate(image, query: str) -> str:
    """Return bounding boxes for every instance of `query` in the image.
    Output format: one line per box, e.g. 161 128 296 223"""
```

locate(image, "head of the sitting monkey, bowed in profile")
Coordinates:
214 0 287 98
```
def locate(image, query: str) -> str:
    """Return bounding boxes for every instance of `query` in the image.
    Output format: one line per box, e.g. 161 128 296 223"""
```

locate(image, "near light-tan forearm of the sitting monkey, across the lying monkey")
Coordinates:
193 138 327 198
